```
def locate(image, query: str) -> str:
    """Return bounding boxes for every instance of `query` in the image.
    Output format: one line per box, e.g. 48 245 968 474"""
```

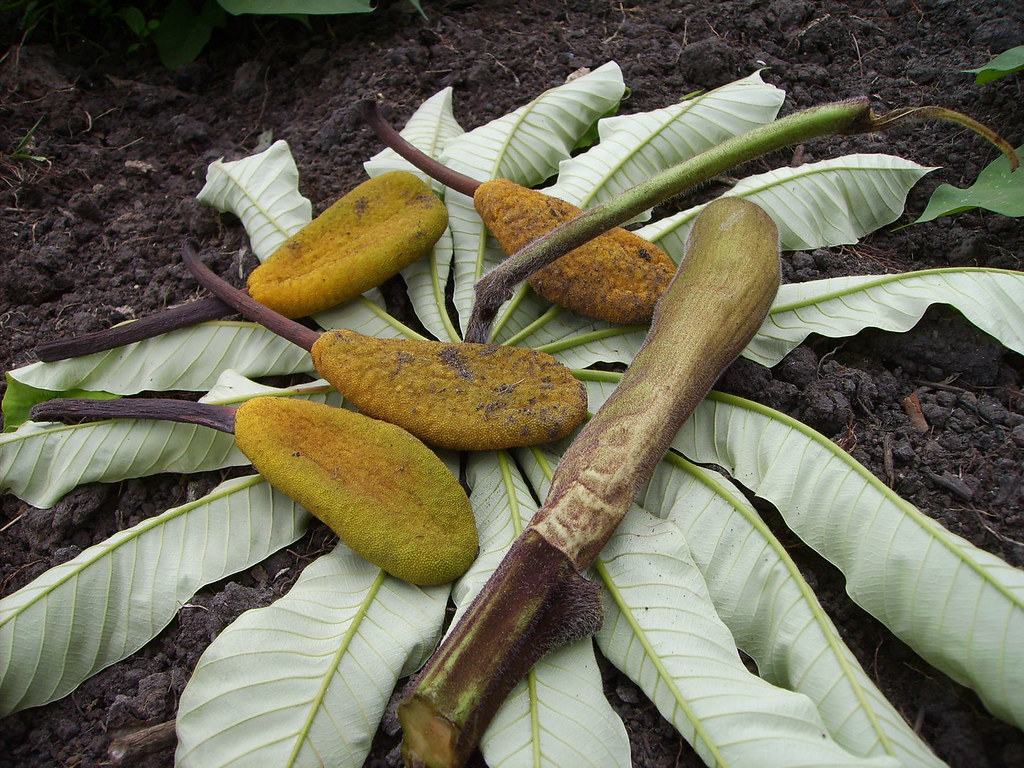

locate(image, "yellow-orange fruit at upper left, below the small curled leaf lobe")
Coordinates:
248 171 447 317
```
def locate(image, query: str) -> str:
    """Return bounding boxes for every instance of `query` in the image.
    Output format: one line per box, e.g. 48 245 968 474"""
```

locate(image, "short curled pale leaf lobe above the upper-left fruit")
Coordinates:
197 140 312 261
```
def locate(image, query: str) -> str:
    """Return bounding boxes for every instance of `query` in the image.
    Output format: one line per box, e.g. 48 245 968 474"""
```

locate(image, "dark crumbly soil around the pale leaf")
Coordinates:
0 0 1024 768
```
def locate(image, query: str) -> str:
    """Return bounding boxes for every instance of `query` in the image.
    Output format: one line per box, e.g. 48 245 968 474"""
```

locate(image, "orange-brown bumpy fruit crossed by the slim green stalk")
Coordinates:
473 179 676 324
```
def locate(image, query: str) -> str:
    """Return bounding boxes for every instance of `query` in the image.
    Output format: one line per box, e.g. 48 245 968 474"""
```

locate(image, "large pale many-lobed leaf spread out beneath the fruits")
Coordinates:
0 63 1024 768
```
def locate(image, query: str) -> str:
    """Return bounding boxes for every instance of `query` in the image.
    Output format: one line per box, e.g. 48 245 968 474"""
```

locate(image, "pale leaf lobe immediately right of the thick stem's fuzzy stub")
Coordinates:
596 508 899 768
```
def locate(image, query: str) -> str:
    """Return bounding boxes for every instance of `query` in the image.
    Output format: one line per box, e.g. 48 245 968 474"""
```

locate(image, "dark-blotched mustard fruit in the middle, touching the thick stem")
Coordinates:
312 330 587 451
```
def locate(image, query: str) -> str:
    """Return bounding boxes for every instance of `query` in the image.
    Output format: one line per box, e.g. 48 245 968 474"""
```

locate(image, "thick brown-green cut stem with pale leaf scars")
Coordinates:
398 198 779 768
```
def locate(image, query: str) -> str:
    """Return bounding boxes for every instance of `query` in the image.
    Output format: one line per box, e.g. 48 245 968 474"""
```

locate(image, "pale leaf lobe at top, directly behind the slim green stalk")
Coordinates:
546 72 785 208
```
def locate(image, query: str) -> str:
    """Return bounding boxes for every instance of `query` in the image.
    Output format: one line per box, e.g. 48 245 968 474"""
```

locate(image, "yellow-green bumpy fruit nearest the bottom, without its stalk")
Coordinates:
234 397 477 586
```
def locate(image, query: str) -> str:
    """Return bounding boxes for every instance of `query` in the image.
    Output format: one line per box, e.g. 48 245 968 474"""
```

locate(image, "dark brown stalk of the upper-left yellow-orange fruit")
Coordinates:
34 296 234 362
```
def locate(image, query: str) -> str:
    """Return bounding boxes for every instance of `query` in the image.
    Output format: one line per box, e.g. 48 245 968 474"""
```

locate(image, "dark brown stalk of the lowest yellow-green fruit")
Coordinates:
29 397 234 434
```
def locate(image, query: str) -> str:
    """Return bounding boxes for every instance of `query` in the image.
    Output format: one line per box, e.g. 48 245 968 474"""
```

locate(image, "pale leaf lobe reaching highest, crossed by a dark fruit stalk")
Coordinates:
441 62 626 331
